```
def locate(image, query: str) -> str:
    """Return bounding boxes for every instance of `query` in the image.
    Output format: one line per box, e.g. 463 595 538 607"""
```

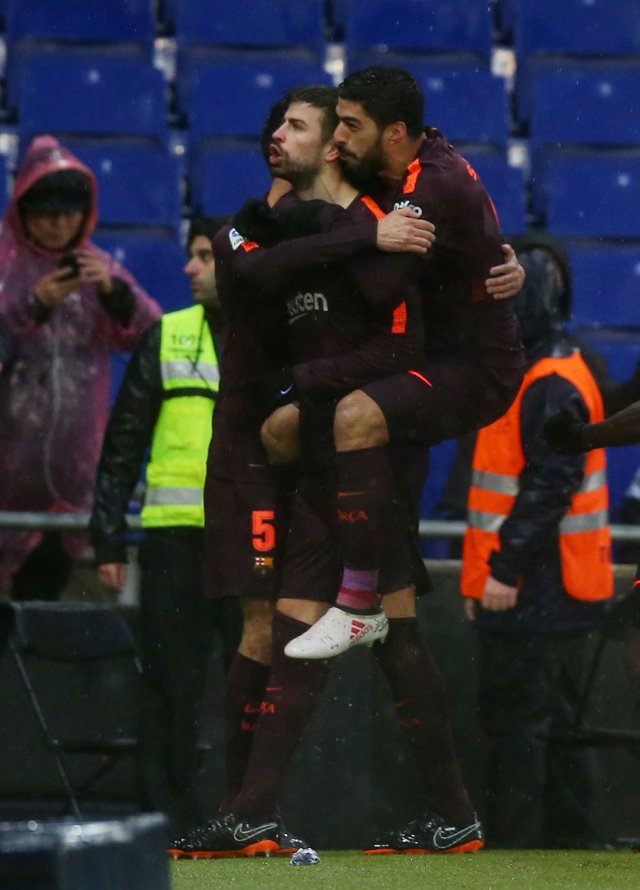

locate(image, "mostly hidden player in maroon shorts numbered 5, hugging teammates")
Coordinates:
172 92 433 855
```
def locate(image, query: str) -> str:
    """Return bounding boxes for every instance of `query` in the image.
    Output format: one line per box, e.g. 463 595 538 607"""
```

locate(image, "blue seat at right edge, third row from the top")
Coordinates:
534 150 640 238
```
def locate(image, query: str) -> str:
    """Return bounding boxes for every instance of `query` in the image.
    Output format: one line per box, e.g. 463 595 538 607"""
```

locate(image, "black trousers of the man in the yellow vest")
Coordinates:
139 528 242 833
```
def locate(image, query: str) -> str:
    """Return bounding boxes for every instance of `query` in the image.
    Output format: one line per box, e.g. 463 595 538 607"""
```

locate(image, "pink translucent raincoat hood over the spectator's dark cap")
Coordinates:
6 136 98 257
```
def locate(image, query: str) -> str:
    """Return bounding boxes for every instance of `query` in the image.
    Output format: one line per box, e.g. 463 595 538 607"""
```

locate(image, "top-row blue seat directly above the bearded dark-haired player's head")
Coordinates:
345 0 492 57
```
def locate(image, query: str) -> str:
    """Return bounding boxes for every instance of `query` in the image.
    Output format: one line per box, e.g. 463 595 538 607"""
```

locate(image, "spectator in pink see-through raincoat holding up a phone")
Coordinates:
0 136 161 598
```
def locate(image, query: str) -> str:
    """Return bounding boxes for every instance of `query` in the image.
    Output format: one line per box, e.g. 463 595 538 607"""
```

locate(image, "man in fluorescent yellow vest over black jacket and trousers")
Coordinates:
90 220 240 832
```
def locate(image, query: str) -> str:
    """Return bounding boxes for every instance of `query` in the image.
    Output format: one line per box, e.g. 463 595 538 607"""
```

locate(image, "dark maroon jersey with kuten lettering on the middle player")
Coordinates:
230 196 423 386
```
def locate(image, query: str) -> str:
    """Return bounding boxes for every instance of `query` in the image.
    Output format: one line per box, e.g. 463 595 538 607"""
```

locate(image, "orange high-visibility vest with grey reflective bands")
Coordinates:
461 352 613 600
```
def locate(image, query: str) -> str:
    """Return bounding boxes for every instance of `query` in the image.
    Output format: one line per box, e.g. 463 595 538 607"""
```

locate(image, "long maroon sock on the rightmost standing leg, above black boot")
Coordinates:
374 618 473 826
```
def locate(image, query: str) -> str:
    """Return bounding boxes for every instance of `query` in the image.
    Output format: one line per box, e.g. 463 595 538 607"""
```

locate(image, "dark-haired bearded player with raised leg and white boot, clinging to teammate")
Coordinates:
286 67 524 659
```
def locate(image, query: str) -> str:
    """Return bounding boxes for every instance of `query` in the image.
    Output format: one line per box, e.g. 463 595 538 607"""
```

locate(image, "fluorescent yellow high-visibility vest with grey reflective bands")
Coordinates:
141 306 220 528
